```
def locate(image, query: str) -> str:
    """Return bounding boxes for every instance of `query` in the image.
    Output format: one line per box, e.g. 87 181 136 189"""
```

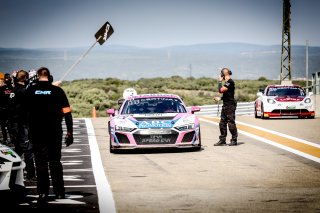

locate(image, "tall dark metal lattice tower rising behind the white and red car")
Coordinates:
280 0 292 84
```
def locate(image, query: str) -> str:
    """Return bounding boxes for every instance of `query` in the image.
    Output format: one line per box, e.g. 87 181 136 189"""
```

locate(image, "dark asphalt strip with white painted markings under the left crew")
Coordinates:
0 119 99 213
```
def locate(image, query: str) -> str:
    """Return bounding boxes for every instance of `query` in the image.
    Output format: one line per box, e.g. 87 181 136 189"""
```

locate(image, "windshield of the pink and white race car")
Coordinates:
121 97 186 114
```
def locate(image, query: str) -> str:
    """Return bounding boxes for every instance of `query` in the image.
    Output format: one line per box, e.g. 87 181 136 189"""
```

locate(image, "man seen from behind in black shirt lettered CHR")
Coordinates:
26 67 73 203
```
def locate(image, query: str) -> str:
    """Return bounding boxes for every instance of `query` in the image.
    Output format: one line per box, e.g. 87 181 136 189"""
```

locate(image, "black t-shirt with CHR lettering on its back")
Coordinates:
26 81 70 136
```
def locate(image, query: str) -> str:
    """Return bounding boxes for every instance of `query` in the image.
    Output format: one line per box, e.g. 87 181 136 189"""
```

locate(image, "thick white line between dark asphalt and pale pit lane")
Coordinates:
85 118 116 213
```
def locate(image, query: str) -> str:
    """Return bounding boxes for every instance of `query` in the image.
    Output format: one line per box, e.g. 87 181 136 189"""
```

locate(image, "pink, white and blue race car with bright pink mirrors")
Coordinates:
107 94 201 152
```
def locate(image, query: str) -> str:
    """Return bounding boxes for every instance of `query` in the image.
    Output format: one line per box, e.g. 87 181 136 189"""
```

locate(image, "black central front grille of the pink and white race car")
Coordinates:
133 132 178 145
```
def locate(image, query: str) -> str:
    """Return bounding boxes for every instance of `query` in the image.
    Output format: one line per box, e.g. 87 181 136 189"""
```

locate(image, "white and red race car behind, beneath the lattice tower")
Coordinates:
254 85 315 119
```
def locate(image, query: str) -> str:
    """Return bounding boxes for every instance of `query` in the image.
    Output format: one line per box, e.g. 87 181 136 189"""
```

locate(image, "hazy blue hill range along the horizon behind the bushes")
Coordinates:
0 43 320 80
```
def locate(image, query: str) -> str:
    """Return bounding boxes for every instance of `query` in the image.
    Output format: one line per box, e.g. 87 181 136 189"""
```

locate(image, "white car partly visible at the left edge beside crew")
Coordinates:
0 143 25 191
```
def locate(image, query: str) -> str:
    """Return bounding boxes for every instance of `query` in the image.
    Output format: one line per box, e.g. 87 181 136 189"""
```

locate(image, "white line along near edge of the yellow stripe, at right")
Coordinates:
199 118 320 163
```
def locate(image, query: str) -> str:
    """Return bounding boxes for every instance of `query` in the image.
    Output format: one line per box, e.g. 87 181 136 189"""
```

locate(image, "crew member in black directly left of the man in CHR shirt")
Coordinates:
8 70 36 181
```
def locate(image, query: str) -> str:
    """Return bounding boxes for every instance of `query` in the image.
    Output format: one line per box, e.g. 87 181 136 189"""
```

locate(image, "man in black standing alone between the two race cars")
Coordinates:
214 68 238 146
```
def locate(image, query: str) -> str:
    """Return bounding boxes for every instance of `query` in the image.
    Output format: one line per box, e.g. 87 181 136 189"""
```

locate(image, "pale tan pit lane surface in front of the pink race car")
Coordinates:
93 118 320 212
